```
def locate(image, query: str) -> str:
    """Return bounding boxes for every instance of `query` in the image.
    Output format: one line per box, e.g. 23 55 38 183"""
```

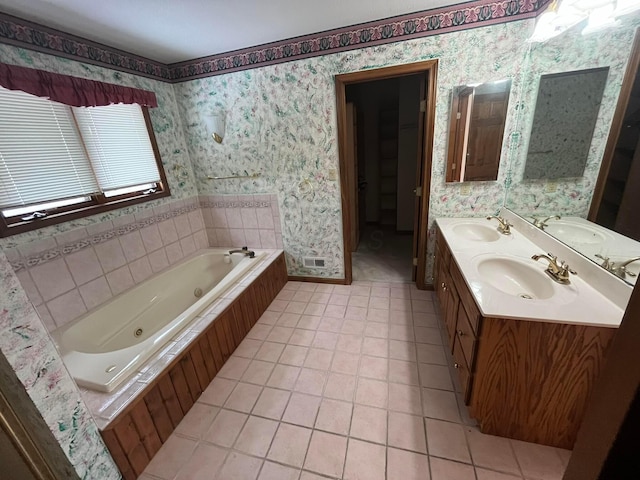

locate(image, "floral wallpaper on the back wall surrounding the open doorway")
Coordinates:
175 20 532 278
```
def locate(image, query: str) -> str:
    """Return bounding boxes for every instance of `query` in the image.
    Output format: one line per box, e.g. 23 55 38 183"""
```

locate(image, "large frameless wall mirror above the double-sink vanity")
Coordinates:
505 14 640 284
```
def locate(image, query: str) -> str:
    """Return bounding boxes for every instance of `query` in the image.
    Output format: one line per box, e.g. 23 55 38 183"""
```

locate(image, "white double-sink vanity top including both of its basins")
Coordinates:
437 218 623 326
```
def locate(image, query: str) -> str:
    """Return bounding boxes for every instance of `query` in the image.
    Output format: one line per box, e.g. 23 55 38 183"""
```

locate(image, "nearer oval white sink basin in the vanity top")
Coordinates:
477 257 555 300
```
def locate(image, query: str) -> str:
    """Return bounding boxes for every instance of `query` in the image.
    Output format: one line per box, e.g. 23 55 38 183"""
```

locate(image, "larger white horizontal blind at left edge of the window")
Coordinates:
0 87 100 208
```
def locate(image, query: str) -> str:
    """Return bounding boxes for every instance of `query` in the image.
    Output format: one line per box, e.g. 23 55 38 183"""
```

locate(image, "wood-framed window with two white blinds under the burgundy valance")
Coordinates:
0 87 169 237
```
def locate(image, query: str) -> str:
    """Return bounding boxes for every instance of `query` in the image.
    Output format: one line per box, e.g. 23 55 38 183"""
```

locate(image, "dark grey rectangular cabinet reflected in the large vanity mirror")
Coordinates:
524 67 609 180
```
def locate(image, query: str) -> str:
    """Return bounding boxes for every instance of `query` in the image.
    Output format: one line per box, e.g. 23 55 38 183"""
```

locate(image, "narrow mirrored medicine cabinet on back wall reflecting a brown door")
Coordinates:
446 79 511 182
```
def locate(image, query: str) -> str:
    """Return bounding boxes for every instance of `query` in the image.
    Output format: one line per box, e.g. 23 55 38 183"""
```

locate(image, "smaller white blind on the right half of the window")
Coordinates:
73 104 160 191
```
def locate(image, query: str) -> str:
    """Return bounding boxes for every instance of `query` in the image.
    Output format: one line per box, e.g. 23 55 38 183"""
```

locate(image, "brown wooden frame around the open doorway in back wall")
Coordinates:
335 59 438 290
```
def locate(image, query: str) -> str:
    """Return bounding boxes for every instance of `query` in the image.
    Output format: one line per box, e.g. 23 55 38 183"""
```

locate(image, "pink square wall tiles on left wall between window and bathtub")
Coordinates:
6 198 209 331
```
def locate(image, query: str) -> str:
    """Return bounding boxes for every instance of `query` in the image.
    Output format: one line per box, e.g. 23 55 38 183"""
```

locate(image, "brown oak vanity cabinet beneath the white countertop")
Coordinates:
434 230 616 449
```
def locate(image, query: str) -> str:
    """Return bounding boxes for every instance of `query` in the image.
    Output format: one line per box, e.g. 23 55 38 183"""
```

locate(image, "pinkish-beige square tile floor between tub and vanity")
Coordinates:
141 282 570 480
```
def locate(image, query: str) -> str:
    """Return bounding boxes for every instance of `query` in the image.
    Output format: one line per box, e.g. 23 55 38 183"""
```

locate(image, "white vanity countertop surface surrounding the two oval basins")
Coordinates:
436 218 624 327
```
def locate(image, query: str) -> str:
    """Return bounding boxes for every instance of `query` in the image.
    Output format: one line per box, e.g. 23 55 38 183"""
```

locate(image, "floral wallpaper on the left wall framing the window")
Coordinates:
0 44 197 248
